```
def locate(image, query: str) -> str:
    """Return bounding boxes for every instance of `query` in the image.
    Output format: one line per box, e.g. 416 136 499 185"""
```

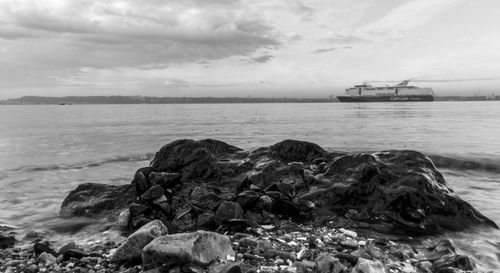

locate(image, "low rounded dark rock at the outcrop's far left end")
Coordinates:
60 183 136 219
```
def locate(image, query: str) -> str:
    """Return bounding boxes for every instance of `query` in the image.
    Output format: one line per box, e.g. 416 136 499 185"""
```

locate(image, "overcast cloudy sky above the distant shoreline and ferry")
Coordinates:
0 0 500 99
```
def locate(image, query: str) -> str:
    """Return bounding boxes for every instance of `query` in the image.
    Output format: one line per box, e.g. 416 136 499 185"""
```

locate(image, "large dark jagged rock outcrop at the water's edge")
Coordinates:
61 139 497 234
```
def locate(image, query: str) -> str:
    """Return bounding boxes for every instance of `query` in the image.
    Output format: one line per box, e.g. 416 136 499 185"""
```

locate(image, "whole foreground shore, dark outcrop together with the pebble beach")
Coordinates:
0 140 497 273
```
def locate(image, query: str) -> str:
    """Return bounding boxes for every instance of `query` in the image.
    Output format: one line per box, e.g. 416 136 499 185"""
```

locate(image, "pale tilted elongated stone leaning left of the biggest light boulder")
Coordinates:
110 220 168 263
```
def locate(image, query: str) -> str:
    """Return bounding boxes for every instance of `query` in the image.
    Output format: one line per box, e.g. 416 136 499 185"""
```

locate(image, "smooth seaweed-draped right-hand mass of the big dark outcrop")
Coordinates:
303 151 498 234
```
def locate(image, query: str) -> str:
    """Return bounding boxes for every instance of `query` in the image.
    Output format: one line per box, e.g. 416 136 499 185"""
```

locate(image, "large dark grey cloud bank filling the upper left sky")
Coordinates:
0 0 280 68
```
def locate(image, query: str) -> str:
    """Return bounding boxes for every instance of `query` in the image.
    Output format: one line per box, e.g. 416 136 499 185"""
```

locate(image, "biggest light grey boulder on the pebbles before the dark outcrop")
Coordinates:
142 231 235 269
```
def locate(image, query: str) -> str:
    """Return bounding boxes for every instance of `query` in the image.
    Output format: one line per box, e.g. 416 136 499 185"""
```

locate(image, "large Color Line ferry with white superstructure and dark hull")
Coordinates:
337 80 434 102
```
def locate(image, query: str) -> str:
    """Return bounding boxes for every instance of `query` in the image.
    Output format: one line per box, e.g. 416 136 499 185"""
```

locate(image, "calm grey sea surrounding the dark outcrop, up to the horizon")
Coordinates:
0 101 500 271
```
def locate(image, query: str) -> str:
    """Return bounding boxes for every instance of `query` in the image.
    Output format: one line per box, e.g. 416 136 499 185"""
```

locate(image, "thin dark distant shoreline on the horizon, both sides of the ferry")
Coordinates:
0 96 500 105
